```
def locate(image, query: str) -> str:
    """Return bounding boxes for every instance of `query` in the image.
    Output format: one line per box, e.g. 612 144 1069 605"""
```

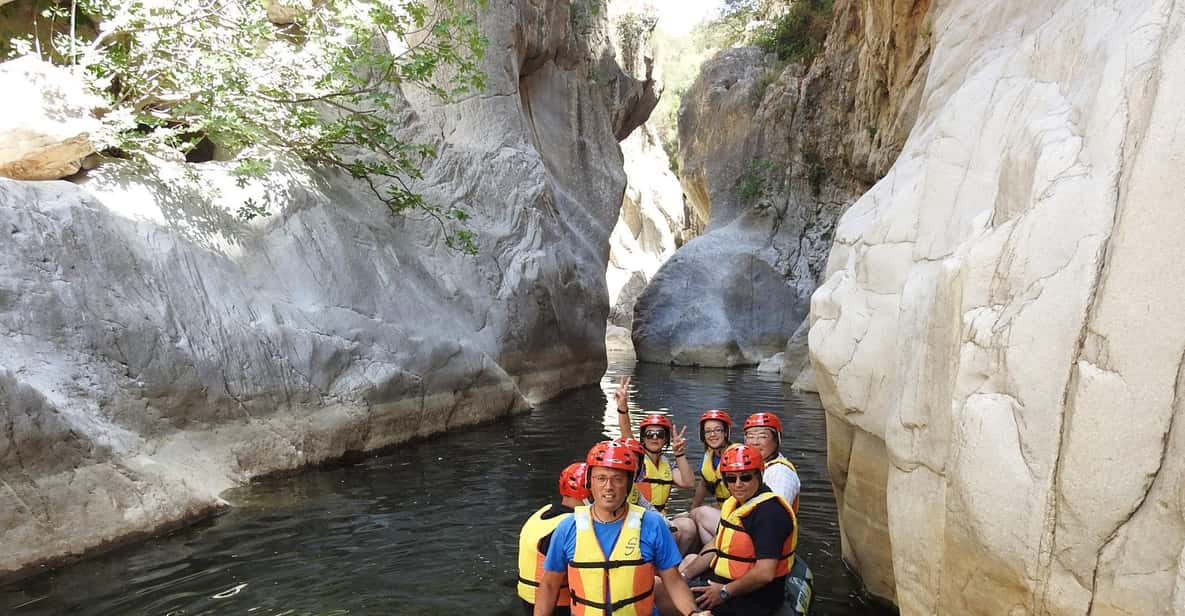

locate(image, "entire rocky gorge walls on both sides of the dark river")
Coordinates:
0 0 1185 616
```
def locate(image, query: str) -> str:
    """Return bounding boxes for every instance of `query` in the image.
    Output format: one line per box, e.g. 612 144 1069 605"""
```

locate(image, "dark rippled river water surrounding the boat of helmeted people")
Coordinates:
0 354 885 616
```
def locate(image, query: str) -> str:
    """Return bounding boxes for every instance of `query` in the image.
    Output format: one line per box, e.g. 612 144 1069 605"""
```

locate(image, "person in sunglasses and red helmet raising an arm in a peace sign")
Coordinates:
614 377 696 513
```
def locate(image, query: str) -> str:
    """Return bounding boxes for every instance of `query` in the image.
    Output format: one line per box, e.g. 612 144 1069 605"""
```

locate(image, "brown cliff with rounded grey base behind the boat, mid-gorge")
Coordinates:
633 0 929 366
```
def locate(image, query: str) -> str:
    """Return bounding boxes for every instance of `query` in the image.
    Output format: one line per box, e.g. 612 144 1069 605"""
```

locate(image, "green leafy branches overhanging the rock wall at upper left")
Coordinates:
8 0 485 254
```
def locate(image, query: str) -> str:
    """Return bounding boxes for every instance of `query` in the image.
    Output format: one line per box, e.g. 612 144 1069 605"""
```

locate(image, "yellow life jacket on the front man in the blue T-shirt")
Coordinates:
568 505 655 616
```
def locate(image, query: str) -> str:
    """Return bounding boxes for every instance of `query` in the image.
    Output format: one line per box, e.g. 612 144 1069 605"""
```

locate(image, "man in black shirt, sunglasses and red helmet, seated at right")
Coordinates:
684 444 799 616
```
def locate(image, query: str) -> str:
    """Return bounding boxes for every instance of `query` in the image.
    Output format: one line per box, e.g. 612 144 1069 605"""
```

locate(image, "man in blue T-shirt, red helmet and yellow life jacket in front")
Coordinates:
534 441 711 616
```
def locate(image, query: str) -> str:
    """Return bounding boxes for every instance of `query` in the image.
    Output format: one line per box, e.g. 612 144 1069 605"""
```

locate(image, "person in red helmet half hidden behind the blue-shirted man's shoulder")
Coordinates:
518 462 591 616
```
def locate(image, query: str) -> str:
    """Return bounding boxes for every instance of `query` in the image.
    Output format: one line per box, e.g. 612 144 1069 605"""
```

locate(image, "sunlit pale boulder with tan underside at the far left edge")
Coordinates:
0 56 103 180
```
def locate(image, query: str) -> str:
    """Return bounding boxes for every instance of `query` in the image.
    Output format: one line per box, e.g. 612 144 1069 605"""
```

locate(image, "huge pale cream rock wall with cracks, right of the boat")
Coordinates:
811 0 1185 616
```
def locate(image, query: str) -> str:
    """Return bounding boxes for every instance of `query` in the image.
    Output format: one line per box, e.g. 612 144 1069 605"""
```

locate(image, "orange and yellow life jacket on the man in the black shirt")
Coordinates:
712 492 799 583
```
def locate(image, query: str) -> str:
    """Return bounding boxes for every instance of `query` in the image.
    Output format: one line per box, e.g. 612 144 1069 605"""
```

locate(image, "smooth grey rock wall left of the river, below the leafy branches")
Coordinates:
0 1 654 573
